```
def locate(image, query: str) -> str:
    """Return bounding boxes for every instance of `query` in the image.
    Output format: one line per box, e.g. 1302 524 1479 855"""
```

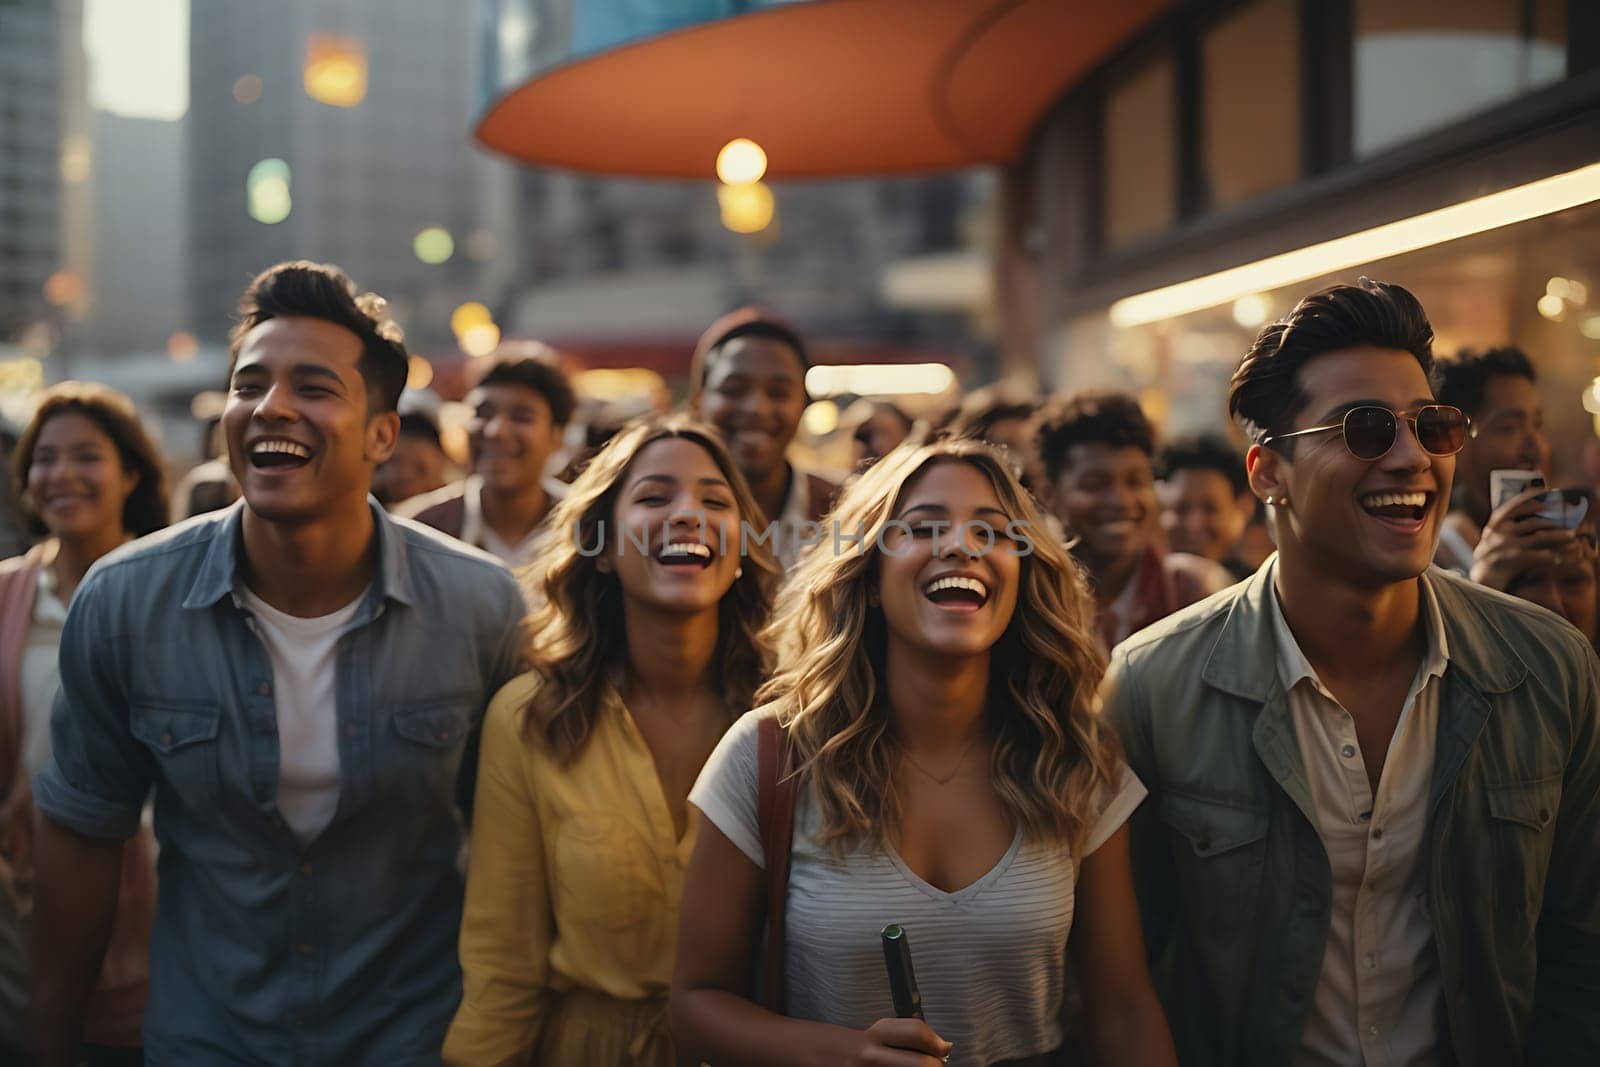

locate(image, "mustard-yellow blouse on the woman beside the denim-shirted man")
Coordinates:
445 673 699 1067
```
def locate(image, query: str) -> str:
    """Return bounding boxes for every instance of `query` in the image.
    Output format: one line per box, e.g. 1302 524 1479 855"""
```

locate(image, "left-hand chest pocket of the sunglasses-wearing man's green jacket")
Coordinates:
1160 792 1267 936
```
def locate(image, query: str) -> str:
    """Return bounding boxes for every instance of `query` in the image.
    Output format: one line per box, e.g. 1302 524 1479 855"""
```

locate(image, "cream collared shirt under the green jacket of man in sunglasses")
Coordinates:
1269 563 1450 1067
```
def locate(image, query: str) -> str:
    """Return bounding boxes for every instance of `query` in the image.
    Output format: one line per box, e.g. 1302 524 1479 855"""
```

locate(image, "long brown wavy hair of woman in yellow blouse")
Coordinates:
522 413 779 763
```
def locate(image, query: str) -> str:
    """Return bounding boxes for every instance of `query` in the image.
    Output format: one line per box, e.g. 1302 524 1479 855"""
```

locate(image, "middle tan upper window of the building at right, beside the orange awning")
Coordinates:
1200 0 1301 208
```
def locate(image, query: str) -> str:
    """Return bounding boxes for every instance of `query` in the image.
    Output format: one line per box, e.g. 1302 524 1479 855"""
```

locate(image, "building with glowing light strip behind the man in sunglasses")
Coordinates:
1003 0 1600 477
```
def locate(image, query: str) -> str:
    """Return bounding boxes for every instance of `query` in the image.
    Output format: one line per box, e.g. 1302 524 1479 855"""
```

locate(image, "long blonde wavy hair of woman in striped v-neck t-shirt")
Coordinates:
755 438 1120 856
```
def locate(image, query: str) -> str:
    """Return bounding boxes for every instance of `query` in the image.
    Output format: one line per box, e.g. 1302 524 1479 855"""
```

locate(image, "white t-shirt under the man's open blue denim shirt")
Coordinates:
243 589 366 845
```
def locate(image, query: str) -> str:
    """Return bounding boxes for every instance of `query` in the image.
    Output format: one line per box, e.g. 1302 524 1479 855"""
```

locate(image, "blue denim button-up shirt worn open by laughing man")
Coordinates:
35 504 523 1067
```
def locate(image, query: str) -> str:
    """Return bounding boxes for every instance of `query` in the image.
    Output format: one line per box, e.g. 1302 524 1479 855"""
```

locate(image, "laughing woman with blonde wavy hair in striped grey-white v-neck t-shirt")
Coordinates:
672 440 1176 1067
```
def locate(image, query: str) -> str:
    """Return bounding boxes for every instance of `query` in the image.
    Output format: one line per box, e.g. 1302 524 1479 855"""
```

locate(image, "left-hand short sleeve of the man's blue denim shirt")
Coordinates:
34 573 154 840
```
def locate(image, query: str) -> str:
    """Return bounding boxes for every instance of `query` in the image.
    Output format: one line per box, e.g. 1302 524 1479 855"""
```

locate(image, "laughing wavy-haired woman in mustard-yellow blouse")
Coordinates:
445 416 778 1067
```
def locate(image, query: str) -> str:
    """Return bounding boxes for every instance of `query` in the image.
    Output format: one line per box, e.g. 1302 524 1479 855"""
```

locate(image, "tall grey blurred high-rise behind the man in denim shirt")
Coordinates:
189 0 506 352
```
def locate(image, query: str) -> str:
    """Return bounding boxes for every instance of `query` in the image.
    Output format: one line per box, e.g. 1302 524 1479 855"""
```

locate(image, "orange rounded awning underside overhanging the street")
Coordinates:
477 0 1171 179
